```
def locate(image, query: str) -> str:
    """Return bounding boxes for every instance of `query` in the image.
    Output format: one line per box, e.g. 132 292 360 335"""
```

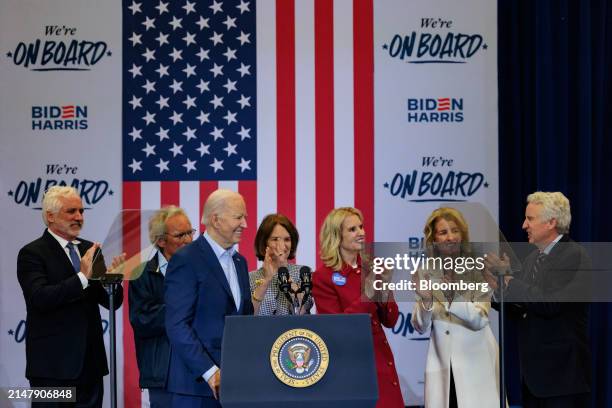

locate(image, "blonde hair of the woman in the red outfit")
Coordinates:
319 207 363 271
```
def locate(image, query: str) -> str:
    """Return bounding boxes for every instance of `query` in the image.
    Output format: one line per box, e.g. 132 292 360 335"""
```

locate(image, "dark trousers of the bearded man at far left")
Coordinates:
30 377 104 408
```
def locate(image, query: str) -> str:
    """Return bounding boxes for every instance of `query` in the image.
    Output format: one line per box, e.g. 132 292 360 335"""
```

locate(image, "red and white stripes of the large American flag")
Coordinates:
123 0 374 407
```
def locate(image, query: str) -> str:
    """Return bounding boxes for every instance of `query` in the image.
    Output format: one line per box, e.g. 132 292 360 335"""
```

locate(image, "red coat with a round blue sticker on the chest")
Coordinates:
312 264 404 408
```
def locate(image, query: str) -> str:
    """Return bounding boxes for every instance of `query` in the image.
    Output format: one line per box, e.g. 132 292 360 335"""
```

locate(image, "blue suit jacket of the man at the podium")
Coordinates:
165 236 253 397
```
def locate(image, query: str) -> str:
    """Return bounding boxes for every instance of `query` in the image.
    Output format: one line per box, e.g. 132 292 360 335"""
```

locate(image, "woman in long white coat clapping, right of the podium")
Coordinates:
412 208 499 408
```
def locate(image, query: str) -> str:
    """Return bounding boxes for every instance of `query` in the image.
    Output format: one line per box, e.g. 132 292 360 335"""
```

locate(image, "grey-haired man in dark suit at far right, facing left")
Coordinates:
488 192 591 408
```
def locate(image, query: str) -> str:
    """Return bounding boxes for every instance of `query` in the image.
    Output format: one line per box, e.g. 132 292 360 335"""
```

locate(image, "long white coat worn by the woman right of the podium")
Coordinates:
411 280 499 408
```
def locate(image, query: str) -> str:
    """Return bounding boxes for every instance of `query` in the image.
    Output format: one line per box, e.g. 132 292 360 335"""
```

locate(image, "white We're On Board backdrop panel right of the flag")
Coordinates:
374 0 498 404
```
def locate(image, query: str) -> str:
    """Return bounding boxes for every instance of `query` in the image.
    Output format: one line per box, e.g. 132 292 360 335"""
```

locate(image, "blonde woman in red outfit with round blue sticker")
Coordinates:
312 207 404 408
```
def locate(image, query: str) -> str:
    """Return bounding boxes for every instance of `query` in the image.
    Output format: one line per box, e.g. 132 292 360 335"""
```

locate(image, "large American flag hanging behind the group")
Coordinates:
122 0 374 407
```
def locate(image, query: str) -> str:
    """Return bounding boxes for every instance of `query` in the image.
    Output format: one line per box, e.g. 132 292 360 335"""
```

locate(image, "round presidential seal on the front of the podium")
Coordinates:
270 329 329 388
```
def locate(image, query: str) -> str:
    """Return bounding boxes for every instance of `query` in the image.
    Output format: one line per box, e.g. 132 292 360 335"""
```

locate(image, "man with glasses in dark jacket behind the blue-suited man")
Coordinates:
128 205 195 408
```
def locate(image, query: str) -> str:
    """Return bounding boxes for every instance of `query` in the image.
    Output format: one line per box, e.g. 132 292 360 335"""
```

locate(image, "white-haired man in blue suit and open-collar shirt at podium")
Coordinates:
165 190 253 408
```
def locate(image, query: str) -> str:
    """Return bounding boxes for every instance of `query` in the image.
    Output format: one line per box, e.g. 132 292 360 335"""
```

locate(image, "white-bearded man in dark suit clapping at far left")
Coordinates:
17 186 123 407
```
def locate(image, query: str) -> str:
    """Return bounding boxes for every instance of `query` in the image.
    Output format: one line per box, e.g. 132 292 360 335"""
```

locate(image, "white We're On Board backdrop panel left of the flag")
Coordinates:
0 0 122 405
